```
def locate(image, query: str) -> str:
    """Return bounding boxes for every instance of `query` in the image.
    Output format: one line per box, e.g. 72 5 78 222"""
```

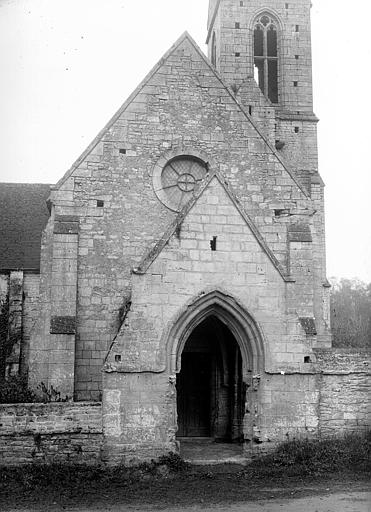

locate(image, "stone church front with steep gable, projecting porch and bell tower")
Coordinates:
1 0 367 461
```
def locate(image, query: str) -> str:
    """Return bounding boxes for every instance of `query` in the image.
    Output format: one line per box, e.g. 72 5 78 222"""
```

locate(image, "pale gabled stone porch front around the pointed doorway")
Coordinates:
103 177 318 461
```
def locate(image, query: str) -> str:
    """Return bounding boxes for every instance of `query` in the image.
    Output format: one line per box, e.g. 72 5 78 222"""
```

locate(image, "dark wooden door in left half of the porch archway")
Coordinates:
177 352 212 437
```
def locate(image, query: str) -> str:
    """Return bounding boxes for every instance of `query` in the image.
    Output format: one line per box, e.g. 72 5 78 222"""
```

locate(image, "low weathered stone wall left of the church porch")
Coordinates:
0 402 103 466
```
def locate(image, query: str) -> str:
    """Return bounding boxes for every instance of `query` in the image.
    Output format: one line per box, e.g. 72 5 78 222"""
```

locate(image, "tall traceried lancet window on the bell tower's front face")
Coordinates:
254 14 278 103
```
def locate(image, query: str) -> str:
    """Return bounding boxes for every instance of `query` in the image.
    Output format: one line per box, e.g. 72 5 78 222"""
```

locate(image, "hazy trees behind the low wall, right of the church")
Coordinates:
331 279 371 348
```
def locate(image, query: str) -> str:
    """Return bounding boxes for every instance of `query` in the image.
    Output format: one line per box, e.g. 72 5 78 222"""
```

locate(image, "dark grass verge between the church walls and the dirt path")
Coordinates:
0 433 371 510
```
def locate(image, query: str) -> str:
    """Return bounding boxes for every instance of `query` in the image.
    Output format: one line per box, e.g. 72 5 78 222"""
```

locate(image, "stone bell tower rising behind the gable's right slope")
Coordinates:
207 0 318 178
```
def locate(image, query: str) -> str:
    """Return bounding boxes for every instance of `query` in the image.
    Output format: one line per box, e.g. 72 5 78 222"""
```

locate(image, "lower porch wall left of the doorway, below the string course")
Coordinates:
103 372 176 465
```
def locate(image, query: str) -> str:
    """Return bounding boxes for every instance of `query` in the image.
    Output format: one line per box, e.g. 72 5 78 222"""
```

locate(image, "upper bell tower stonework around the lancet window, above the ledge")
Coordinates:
209 0 312 111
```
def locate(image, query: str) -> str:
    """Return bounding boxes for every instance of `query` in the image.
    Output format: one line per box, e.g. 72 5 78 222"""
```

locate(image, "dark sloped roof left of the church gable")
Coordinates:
0 183 51 270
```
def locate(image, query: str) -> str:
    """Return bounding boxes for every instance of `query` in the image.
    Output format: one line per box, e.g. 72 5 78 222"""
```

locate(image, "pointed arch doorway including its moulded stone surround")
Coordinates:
166 290 265 460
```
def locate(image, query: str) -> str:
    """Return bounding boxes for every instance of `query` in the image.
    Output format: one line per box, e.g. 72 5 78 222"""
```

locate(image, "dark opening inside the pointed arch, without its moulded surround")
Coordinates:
176 315 246 443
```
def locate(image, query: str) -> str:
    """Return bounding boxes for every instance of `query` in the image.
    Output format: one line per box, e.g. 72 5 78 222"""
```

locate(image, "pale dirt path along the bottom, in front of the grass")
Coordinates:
7 491 371 512
